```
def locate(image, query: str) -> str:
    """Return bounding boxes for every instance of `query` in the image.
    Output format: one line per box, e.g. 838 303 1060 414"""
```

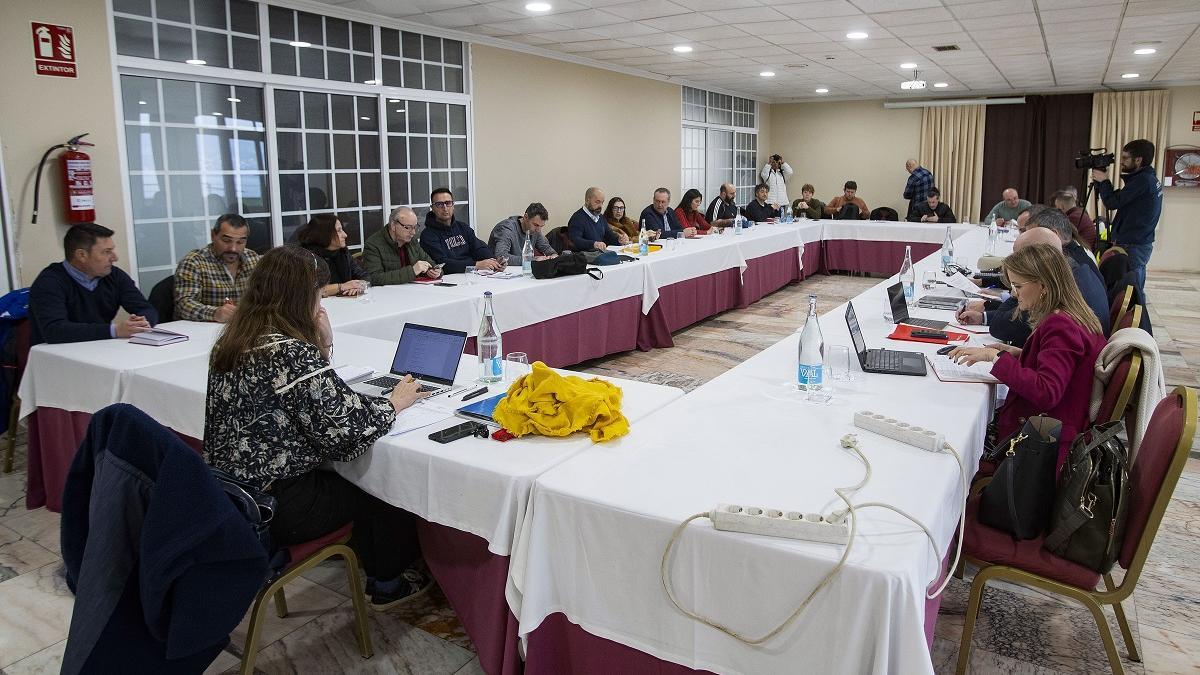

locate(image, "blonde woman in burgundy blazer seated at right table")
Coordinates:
950 244 1105 468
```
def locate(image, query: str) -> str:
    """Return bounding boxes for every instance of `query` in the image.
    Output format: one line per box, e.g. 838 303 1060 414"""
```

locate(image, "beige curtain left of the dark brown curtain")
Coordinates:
920 106 988 221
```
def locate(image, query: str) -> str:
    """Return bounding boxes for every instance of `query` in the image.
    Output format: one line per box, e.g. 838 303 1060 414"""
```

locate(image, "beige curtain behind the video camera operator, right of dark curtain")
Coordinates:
1080 90 1171 217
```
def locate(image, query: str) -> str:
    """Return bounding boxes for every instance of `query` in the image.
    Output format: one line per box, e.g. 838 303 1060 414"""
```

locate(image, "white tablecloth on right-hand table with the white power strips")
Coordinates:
509 227 1008 673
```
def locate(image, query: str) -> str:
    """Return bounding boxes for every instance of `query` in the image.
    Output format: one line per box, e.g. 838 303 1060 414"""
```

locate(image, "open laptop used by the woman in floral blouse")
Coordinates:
352 323 467 396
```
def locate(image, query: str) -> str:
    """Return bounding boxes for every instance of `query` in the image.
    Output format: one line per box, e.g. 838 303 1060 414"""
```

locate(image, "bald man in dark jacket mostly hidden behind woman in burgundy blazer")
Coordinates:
954 225 1109 348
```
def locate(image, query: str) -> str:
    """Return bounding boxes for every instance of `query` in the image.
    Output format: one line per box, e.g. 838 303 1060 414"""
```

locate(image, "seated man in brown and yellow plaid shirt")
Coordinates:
175 214 258 323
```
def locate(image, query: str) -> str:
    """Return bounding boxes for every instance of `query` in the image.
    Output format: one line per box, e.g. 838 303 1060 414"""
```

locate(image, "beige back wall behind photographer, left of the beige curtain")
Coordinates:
758 101 920 216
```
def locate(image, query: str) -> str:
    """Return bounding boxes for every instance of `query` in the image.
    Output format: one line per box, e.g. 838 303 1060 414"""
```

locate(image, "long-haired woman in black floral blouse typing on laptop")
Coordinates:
204 246 431 608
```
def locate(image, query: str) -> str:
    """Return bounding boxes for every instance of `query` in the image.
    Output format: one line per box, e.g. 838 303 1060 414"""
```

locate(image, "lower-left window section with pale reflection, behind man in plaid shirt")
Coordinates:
121 76 271 291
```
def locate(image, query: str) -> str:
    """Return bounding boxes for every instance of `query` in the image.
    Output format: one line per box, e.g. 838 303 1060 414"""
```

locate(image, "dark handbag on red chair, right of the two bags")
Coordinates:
1042 419 1129 566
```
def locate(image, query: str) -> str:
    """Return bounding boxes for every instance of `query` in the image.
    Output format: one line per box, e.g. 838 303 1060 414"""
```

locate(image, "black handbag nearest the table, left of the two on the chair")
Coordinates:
979 414 1062 539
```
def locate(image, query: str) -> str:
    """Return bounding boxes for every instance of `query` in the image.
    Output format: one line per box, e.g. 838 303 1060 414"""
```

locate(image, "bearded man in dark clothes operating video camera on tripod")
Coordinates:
1092 138 1163 291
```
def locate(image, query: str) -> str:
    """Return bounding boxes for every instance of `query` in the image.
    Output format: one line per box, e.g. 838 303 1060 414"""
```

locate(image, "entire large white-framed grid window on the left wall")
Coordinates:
113 0 472 284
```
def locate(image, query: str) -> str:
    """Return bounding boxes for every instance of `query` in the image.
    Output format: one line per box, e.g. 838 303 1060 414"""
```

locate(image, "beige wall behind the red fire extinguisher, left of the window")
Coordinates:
0 0 125 285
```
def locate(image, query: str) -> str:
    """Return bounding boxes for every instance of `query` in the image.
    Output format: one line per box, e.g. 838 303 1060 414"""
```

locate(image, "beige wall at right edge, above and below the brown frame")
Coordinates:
1150 86 1200 271
